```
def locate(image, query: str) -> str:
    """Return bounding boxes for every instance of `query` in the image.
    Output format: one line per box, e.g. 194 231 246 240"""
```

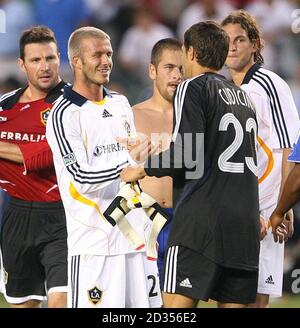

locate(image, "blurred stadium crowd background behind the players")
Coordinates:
0 0 300 307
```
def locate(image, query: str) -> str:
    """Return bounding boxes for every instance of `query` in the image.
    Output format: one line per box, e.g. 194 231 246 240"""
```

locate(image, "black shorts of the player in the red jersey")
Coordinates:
1 198 67 303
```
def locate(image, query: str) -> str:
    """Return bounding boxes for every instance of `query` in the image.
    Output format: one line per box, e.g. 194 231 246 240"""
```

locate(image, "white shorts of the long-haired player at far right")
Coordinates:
257 206 284 297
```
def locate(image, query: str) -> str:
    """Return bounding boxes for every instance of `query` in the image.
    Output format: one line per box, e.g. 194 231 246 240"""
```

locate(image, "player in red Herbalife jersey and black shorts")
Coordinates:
0 26 67 307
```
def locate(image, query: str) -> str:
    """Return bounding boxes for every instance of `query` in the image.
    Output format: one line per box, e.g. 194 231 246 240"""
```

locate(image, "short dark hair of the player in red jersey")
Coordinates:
19 26 57 60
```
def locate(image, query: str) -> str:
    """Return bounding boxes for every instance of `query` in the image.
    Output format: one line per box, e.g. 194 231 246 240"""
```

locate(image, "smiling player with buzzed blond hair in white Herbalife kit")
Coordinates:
46 27 161 308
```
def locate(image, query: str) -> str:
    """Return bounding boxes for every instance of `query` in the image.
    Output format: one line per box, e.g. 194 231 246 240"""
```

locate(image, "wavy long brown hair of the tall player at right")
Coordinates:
221 9 264 65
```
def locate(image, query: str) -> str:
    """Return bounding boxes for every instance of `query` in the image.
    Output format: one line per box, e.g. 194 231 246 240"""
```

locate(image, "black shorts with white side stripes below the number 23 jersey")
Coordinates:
163 246 258 304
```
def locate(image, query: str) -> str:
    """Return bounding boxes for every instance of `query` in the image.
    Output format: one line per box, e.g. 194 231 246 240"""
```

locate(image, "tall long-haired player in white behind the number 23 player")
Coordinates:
222 10 299 308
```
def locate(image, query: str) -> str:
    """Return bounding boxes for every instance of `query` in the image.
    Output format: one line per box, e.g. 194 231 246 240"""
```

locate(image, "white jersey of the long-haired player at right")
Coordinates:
241 64 300 210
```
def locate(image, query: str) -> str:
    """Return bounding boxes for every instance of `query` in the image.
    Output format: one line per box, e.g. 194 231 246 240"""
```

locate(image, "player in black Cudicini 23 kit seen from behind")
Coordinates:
121 22 259 307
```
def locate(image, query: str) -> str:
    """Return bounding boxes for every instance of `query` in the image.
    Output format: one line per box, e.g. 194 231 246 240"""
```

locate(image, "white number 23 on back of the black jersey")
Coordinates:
218 113 257 176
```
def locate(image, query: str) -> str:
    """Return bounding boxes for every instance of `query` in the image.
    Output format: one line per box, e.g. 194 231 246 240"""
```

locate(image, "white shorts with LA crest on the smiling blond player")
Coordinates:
68 252 162 308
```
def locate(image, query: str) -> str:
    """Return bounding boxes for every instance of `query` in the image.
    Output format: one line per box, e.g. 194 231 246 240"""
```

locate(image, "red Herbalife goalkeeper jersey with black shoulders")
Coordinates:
0 82 64 202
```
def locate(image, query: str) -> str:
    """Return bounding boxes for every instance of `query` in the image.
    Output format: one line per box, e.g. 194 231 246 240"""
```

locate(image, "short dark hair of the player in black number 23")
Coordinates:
184 21 229 70
